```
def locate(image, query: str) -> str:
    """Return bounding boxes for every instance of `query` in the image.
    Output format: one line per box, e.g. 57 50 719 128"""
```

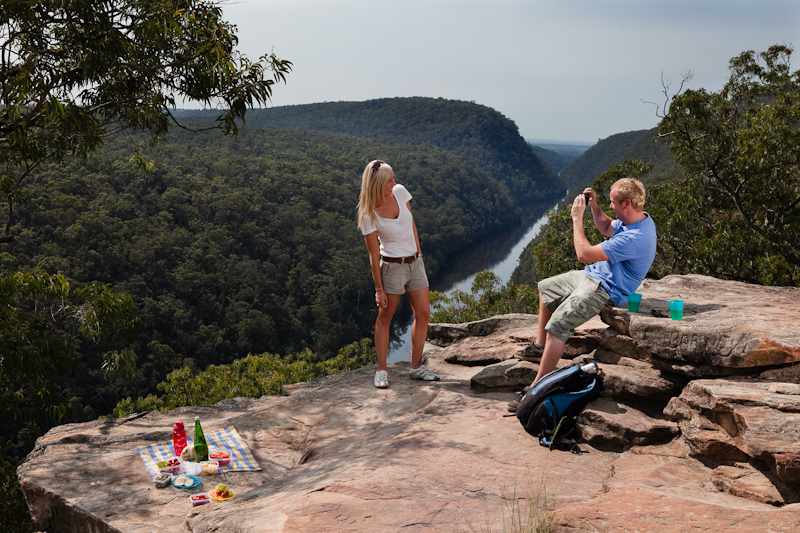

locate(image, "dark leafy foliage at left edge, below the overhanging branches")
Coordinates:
0 271 141 455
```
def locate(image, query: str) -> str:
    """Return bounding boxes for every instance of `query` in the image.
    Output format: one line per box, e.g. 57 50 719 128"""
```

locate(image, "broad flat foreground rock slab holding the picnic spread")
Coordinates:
19 350 800 533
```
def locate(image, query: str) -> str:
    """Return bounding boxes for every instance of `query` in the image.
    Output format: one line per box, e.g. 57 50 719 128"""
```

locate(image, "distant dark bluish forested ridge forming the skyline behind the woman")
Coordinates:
177 97 564 204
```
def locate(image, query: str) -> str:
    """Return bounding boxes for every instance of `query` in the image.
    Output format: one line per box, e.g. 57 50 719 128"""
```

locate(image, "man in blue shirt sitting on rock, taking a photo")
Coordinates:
509 178 656 400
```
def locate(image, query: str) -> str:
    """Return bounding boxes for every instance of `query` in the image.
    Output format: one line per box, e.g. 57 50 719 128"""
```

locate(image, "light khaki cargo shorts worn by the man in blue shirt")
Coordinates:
539 270 611 342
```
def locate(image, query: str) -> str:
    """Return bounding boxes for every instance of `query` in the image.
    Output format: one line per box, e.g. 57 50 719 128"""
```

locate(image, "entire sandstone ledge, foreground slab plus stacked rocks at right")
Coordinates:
18 276 800 533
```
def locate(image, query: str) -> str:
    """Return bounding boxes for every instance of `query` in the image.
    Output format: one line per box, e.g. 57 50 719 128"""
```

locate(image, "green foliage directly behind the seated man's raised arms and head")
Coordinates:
511 159 658 285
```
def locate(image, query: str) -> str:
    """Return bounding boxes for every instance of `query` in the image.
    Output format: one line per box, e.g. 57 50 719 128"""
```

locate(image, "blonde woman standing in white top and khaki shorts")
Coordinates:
358 160 439 389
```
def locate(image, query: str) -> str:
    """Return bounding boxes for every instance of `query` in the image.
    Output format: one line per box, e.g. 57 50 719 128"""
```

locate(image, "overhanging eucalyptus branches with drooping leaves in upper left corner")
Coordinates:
0 0 291 242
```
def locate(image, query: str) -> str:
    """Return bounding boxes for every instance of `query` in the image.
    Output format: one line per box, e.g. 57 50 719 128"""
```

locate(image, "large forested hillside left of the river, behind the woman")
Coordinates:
0 128 519 420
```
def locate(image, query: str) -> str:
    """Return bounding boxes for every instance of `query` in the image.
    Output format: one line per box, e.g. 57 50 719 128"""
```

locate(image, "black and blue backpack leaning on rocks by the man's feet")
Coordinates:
517 359 603 453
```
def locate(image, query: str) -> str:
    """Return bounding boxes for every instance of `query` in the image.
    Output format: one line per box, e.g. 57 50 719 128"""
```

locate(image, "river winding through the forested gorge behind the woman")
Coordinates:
387 205 558 363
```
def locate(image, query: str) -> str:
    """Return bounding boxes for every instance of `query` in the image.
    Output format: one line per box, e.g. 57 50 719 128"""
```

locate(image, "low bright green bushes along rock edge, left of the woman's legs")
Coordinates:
114 339 378 417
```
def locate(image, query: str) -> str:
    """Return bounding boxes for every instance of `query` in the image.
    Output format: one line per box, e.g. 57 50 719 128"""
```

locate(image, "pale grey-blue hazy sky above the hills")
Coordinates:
214 0 800 143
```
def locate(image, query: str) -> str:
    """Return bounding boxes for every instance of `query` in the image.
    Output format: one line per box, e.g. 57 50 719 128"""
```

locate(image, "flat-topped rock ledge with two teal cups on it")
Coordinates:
602 275 800 377
